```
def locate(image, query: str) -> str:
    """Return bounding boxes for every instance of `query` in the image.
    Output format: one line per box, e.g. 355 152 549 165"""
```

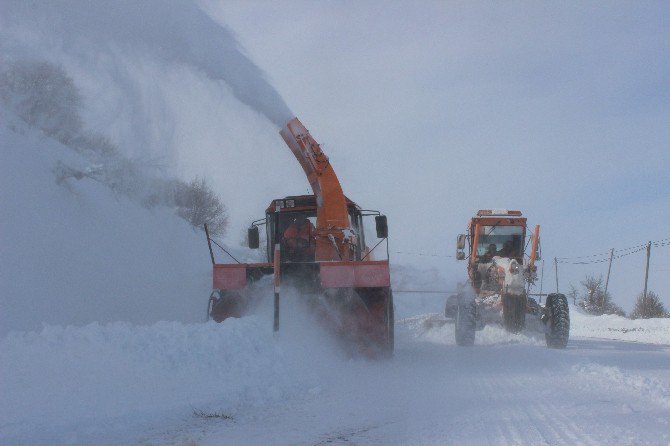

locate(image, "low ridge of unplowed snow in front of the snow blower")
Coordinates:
0 297 343 444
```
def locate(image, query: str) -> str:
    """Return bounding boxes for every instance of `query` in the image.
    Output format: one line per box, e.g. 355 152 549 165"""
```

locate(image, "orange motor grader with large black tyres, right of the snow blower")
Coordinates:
445 209 570 348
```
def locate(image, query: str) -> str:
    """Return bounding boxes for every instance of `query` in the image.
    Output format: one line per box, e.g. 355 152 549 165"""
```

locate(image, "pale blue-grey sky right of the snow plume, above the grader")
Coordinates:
206 1 670 310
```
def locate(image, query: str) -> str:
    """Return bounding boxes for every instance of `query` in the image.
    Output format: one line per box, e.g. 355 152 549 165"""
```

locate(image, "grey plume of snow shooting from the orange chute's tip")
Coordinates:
0 0 293 128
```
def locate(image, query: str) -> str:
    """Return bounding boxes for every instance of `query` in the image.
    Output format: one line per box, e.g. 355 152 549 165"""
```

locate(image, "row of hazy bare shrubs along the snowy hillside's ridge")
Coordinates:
0 62 227 235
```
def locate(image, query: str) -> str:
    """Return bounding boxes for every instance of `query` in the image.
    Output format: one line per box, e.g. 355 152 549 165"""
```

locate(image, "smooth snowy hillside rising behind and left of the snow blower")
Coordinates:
0 108 215 334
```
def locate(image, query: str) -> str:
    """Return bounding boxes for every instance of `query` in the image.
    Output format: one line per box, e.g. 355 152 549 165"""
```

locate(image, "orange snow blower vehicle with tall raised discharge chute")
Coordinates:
207 118 394 356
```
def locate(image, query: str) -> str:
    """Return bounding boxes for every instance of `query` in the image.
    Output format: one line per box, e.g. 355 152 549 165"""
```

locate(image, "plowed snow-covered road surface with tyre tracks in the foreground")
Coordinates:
180 320 670 445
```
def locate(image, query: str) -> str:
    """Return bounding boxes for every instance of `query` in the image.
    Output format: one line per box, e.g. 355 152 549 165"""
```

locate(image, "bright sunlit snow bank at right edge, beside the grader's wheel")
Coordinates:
570 306 670 345
